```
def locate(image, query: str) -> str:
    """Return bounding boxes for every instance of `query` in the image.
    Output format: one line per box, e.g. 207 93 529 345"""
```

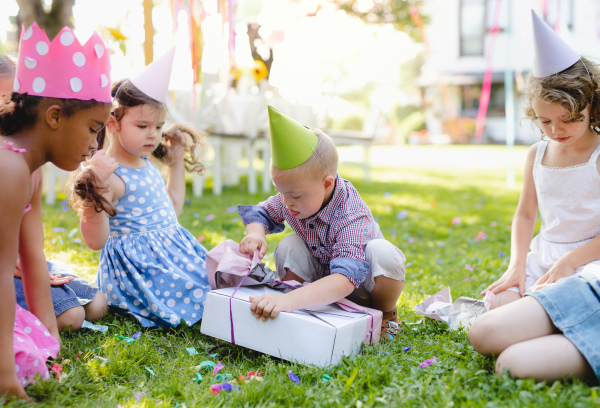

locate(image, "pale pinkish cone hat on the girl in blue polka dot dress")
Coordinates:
131 47 175 103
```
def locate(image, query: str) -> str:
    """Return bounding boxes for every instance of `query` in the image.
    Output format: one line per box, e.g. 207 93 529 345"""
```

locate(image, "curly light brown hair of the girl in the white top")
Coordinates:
523 57 600 129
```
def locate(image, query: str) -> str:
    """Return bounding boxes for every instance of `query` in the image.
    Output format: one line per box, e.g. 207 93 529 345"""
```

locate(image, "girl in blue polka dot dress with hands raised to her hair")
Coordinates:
72 50 210 327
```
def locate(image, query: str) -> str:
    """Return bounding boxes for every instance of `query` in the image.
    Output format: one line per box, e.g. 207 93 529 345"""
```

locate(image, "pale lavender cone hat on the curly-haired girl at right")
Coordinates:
531 10 581 78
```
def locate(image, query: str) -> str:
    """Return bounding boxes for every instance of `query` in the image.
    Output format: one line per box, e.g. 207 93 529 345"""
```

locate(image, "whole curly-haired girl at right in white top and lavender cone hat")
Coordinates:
469 12 600 381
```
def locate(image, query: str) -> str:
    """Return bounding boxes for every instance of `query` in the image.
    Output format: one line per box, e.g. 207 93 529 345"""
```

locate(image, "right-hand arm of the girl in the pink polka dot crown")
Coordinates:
19 169 60 341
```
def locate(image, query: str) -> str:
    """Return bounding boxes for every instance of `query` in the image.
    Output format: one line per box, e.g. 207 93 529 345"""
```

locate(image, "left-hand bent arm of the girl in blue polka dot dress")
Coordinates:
79 150 121 251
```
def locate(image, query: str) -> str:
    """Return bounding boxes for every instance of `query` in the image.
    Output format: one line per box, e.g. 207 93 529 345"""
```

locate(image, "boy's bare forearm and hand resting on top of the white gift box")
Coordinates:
250 273 354 321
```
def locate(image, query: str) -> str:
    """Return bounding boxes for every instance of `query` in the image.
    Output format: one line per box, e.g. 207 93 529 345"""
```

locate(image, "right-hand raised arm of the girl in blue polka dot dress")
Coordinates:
164 127 185 217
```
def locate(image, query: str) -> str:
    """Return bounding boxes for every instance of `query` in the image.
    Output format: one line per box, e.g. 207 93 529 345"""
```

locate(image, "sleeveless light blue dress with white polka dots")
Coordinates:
98 159 210 327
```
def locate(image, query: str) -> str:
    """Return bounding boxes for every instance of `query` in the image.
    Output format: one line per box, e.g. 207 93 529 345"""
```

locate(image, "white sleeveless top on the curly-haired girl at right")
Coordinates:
533 141 600 244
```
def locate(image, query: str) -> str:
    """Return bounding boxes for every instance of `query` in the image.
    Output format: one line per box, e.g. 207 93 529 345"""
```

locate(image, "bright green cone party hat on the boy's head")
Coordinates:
268 106 319 170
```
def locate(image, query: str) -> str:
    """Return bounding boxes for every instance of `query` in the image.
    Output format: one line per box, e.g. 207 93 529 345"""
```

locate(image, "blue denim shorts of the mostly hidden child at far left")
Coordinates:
14 261 98 316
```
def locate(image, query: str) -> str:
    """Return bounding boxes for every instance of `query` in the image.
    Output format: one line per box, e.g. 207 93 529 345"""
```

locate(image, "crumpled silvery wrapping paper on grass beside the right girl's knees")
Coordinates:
415 286 487 330
